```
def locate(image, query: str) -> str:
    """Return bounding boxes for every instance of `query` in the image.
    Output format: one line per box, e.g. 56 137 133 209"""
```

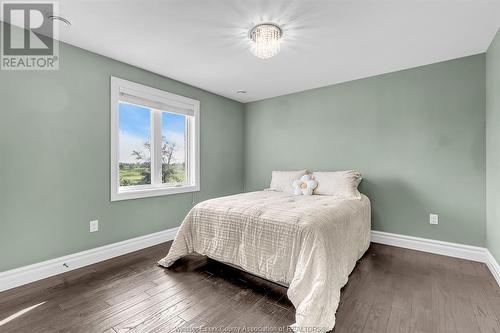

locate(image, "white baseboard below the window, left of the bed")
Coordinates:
0 227 178 292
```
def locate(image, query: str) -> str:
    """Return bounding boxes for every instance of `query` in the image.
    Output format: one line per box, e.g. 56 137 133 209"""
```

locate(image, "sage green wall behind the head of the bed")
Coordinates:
245 54 486 246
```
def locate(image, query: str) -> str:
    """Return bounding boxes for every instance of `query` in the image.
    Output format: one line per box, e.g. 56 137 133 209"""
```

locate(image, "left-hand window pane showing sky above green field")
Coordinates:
119 102 151 186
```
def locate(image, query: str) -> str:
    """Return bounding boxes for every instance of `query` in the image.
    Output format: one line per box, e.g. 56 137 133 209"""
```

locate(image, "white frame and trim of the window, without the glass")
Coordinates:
111 76 200 201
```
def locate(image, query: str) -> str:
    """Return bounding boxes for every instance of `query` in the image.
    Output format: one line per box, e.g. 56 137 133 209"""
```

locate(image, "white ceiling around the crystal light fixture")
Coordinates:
22 0 500 102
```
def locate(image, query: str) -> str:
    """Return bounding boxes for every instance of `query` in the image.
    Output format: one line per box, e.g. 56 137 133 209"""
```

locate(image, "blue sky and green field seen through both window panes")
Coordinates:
119 103 187 186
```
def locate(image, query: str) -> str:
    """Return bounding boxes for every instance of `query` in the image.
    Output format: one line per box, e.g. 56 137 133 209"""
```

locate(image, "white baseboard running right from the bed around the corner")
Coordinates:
371 230 500 286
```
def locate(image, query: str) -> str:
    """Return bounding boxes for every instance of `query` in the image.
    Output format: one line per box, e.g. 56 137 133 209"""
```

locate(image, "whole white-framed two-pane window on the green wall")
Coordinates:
111 77 200 201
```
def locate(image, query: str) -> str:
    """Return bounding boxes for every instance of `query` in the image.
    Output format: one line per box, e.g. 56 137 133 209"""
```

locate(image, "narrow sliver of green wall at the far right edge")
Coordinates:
486 28 500 262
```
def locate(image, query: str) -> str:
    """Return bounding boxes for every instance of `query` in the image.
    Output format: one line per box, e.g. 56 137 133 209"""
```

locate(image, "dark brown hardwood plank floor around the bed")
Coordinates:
0 244 500 333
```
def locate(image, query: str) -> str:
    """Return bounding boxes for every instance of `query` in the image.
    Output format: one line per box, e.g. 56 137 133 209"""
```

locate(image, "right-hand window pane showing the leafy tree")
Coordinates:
161 112 187 184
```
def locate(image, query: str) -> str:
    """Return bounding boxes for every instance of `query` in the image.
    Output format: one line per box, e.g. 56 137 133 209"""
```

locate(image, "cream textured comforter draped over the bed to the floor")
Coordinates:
159 191 371 332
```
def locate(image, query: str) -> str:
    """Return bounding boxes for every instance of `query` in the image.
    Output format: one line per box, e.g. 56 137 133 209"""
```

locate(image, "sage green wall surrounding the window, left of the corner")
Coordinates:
0 44 244 271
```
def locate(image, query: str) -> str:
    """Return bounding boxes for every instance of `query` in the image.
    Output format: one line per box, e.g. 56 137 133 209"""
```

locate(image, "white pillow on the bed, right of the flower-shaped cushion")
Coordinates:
313 170 362 199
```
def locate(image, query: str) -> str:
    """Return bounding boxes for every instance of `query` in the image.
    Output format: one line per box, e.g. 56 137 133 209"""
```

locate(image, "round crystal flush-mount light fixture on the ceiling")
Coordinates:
250 23 283 59
